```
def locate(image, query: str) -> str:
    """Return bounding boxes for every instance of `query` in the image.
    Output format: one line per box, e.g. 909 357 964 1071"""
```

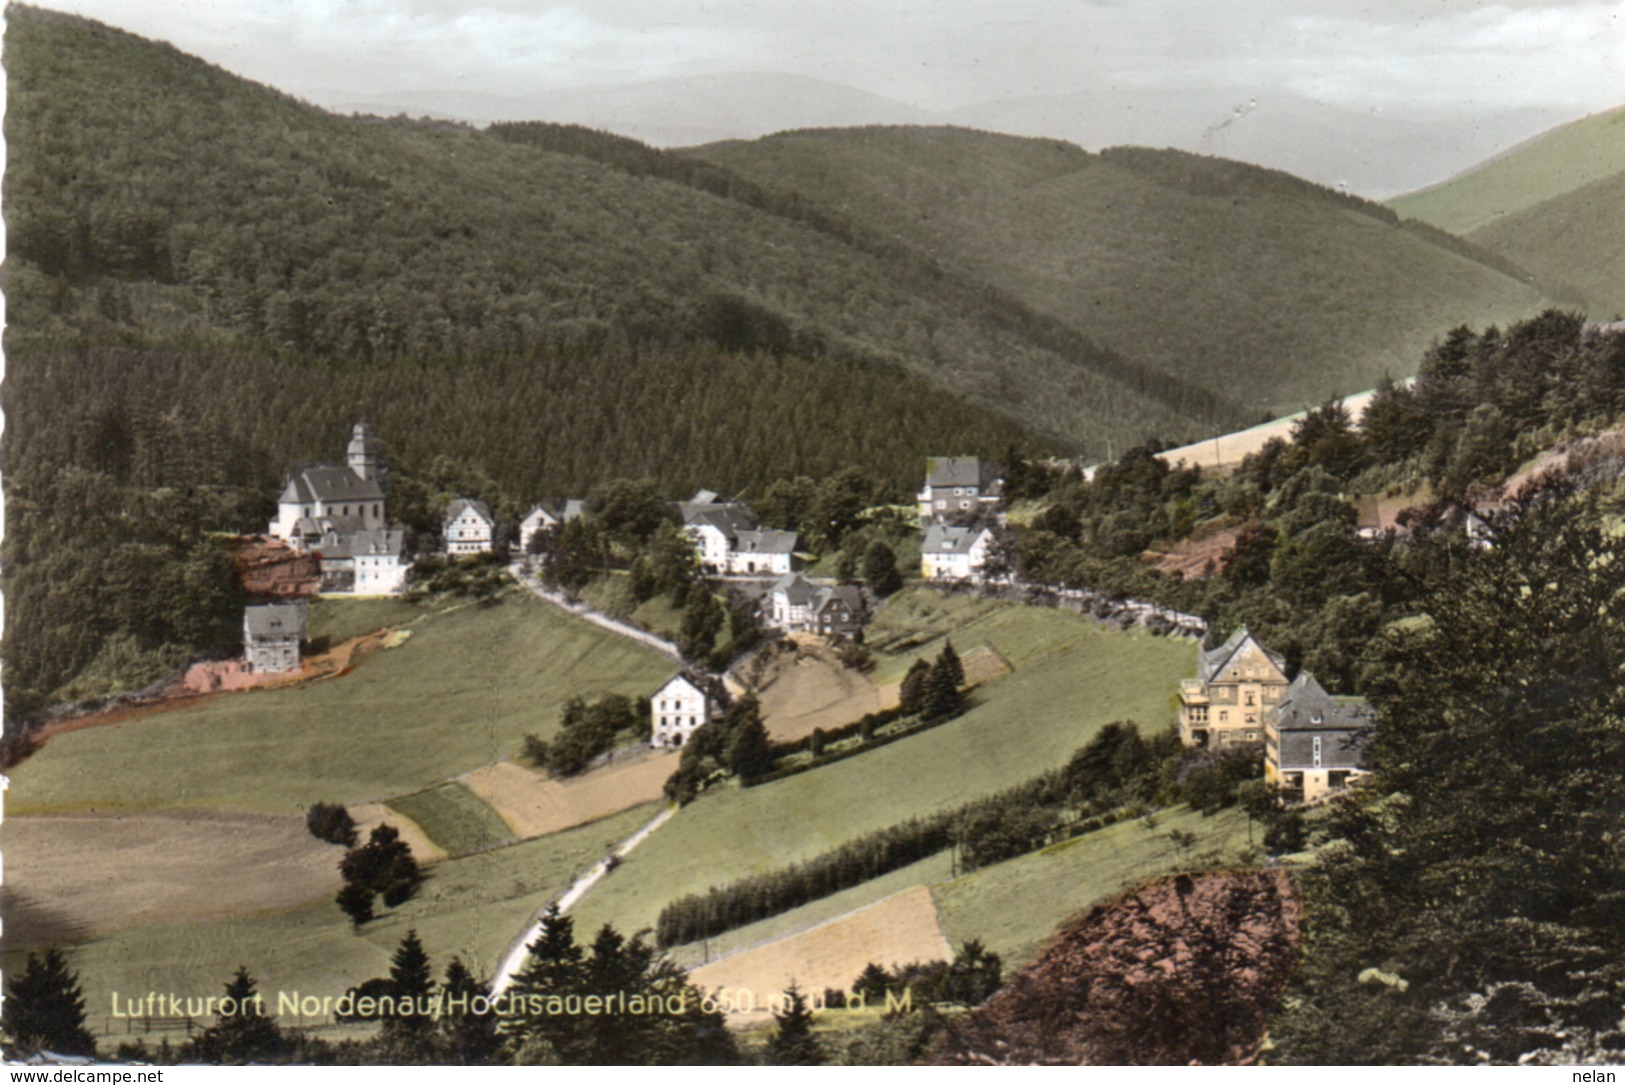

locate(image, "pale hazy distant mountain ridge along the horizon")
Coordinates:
326 71 1568 198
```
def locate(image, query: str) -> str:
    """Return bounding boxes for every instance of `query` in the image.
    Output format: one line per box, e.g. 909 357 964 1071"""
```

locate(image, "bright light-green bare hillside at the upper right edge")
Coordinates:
1388 109 1625 236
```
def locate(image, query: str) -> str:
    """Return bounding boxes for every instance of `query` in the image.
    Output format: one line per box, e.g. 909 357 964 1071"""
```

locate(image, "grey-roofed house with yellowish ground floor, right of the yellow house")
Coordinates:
1264 671 1376 802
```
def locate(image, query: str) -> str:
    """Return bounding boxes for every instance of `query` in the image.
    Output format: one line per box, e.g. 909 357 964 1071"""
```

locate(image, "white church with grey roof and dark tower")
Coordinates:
268 422 390 551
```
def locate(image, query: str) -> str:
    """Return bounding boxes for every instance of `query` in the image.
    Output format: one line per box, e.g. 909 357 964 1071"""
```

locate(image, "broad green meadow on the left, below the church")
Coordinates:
7 591 670 814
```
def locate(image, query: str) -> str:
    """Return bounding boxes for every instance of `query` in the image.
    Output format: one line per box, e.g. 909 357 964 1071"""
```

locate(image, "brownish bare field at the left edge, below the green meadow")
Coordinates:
3 811 343 949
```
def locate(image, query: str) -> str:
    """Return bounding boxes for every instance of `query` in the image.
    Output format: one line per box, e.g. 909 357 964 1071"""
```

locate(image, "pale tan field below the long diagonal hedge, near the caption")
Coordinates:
689 885 952 1025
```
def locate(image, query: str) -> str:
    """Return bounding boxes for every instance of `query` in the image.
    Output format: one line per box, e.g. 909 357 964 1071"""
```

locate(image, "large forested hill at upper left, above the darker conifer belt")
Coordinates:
5 6 1243 458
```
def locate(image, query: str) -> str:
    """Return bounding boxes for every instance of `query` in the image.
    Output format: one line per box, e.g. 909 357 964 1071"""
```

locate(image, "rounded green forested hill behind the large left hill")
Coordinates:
687 128 1541 414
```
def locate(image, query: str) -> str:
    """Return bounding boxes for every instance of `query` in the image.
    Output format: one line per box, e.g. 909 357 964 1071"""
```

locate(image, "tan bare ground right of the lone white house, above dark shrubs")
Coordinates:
757 637 897 742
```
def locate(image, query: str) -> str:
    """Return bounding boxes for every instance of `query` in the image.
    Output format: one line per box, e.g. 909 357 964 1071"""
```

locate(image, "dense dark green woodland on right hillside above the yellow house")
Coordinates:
1019 310 1625 692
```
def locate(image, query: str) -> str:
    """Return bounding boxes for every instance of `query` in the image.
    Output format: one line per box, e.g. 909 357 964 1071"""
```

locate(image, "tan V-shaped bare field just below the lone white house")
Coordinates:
462 750 678 840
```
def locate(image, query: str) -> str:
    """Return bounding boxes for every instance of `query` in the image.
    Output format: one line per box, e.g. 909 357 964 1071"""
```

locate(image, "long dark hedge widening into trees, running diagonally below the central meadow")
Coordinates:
655 723 1263 945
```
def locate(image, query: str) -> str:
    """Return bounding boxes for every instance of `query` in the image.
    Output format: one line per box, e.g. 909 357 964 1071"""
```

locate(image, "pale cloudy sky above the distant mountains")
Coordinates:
22 0 1625 115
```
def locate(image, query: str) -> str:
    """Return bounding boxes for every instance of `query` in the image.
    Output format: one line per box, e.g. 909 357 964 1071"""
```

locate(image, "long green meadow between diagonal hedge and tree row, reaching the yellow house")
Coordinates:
577 591 1193 931
